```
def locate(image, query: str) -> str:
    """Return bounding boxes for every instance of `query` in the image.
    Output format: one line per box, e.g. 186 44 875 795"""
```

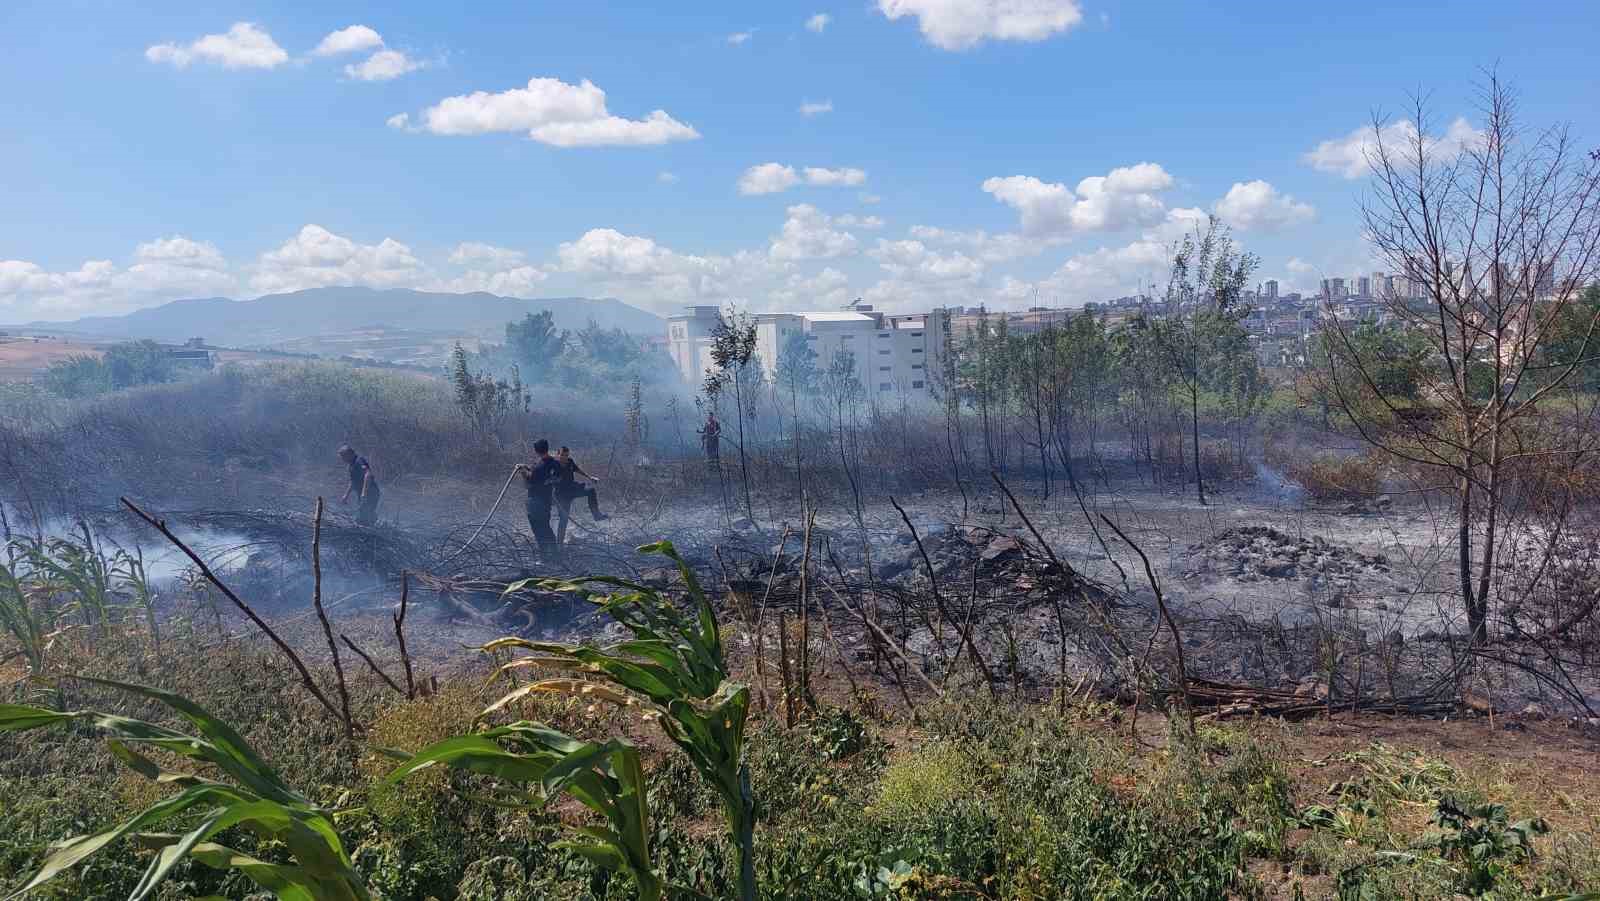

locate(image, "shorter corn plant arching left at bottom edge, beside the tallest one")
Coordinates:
386 720 664 901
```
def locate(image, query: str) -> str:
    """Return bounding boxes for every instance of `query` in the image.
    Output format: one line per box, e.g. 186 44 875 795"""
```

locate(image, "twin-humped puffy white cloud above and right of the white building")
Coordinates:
982 163 1173 237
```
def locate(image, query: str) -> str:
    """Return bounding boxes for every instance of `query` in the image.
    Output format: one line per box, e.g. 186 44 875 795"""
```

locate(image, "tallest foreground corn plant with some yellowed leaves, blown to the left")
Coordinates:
483 541 755 901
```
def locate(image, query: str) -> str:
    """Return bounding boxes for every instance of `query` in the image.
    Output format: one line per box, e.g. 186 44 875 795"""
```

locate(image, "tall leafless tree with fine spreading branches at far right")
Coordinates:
1325 72 1600 645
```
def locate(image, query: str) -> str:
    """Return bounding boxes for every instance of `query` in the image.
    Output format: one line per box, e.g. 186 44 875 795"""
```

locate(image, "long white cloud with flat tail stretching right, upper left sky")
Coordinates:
406 78 699 147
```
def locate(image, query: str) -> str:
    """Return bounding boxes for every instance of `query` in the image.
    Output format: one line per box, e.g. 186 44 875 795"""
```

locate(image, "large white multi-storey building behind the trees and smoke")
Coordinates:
667 306 944 400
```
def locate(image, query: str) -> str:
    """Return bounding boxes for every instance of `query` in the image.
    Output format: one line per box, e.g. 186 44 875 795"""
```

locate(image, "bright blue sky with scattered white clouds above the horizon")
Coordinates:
0 0 1600 322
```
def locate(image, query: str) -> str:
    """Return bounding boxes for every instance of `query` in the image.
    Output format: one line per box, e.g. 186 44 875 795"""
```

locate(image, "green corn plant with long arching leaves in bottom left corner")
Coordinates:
0 677 371 901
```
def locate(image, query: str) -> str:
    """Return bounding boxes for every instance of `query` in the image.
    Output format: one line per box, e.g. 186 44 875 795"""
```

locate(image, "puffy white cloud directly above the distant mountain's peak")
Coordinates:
250 226 427 294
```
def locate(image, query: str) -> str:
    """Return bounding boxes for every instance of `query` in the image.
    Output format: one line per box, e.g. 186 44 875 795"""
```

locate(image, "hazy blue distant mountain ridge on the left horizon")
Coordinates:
26 288 666 347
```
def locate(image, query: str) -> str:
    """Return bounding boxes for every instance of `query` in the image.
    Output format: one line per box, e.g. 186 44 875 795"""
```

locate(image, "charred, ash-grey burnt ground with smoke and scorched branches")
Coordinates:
53 454 1600 715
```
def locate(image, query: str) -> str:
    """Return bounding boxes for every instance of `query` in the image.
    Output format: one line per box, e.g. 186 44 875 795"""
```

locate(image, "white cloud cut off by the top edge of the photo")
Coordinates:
878 0 1083 50
